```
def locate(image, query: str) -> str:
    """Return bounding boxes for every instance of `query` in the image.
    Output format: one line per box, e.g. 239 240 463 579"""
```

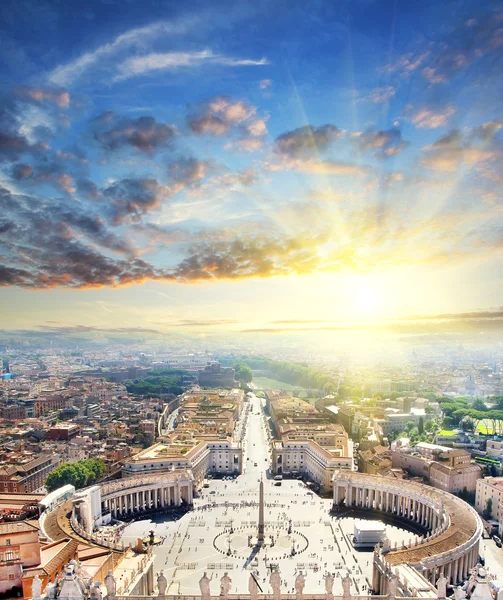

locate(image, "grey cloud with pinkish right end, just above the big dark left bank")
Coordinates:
103 179 172 225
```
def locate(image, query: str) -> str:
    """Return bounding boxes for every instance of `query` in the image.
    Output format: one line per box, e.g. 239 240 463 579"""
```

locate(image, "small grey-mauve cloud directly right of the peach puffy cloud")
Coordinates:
274 124 344 158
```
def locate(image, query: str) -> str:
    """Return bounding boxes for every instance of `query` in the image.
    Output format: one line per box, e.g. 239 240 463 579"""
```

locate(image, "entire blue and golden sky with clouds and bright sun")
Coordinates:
0 0 503 333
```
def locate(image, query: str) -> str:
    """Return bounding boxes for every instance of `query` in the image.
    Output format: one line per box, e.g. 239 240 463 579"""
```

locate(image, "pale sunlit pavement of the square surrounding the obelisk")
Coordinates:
122 397 418 595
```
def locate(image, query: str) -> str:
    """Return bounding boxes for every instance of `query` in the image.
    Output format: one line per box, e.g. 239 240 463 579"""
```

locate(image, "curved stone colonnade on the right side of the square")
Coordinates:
333 471 483 595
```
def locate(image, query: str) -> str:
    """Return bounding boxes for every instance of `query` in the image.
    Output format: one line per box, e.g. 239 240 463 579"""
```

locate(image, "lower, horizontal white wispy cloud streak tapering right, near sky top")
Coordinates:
115 50 269 81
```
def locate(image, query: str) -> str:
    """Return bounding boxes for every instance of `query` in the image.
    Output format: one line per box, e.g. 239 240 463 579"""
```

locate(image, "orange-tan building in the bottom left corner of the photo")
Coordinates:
0 521 40 594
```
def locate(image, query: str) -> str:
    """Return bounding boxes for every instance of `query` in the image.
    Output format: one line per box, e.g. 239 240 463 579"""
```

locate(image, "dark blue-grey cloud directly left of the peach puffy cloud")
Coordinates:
92 111 177 154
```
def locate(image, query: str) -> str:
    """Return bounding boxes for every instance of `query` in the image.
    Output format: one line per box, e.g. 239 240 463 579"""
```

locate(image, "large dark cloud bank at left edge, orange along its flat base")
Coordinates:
0 188 166 289
